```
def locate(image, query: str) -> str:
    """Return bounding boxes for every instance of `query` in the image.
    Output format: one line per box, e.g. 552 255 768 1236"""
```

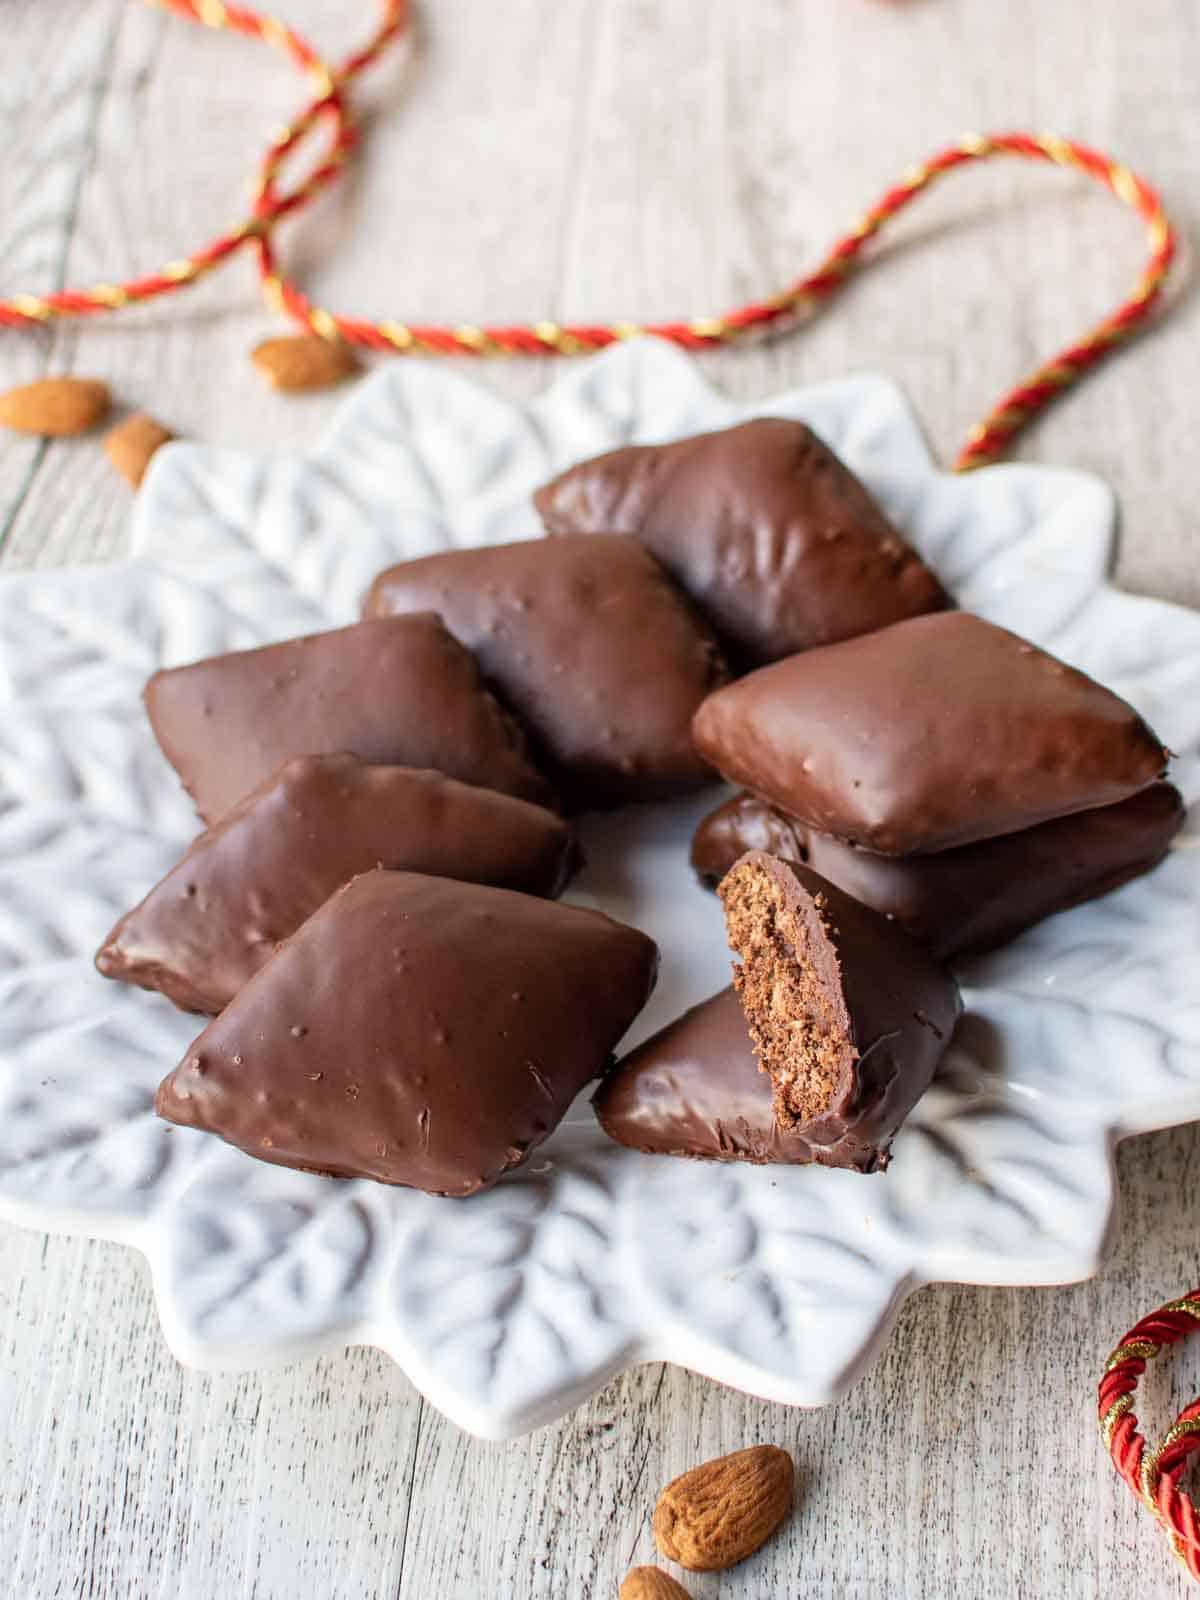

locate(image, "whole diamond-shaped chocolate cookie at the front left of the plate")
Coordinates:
155 872 658 1195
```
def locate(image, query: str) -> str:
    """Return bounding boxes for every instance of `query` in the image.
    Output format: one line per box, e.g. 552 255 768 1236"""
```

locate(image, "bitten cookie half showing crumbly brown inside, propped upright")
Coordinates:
718 851 960 1173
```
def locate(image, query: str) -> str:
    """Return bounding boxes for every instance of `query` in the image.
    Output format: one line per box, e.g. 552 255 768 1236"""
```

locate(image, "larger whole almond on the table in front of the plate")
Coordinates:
654 1445 795 1573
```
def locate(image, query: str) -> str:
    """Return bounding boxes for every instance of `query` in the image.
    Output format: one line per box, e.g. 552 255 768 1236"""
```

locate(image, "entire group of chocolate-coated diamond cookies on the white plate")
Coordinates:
96 419 1181 1197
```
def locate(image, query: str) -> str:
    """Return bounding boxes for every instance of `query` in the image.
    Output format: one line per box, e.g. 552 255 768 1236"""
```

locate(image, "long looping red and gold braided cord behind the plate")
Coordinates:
0 0 1176 470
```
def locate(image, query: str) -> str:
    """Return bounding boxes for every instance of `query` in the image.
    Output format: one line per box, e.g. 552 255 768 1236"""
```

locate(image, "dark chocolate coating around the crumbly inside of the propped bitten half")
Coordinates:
722 851 962 1173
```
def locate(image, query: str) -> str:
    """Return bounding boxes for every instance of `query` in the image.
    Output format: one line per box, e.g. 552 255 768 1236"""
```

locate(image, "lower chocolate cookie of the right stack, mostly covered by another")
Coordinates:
691 784 1184 962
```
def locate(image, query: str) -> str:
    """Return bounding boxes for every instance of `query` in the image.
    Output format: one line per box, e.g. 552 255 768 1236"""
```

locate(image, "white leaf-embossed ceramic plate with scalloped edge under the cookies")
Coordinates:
0 342 1200 1437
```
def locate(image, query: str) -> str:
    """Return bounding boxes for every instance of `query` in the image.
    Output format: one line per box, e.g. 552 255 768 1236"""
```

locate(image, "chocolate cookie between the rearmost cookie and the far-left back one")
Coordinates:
365 538 728 810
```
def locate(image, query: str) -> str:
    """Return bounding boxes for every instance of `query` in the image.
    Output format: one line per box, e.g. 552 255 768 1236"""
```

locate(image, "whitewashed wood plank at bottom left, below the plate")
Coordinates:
0 1227 418 1600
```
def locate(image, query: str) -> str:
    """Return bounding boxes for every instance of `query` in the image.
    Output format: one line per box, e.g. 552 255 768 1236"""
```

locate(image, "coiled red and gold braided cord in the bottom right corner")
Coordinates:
1099 1288 1200 1579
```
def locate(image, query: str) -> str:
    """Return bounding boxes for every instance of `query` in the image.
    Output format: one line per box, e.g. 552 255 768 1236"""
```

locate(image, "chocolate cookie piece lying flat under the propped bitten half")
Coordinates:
592 989 842 1165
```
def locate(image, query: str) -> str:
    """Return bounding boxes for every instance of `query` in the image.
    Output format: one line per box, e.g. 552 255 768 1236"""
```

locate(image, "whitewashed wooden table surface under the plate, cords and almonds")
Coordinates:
0 0 1200 1600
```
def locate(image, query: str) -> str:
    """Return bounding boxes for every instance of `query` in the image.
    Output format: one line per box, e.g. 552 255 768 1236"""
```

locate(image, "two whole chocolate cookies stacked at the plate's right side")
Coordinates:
693 611 1182 960
